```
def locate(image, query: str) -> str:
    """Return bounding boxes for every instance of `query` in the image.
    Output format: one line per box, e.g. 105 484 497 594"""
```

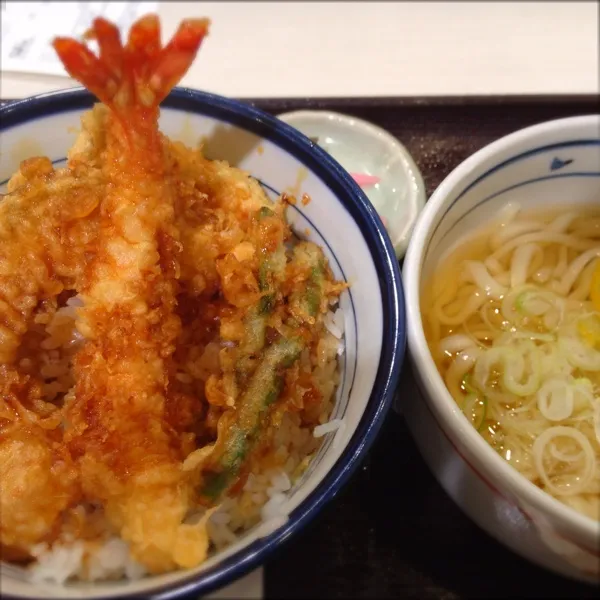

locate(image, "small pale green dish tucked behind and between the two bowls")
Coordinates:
277 110 425 258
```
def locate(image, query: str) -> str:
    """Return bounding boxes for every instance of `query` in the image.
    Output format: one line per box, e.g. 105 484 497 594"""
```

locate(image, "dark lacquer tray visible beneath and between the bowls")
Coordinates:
2 96 600 600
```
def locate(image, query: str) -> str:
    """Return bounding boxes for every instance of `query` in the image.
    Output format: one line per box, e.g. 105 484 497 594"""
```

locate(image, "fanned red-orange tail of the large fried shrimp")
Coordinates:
53 15 210 172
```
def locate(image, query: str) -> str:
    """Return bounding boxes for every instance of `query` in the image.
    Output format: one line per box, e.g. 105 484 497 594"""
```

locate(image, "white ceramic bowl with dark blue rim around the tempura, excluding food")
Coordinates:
0 89 405 598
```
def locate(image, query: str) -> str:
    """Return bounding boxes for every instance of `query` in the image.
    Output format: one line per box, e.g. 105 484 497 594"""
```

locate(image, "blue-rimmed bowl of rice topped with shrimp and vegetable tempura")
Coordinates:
0 16 405 599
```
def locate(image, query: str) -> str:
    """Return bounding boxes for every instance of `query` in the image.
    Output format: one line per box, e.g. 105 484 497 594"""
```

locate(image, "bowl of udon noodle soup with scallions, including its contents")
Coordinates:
403 115 600 582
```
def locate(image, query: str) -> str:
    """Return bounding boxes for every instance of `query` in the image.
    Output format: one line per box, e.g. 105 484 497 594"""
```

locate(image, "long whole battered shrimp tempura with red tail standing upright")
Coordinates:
54 16 208 572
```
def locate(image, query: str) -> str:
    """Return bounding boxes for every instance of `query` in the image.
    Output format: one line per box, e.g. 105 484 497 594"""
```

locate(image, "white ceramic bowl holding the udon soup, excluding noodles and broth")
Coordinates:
402 116 600 582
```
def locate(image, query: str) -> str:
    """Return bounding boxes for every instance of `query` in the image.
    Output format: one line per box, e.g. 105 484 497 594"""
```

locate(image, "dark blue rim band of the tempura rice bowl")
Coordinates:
0 88 406 600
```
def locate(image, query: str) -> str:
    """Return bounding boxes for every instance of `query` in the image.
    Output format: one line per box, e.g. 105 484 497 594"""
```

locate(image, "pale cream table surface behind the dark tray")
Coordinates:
0 1 600 98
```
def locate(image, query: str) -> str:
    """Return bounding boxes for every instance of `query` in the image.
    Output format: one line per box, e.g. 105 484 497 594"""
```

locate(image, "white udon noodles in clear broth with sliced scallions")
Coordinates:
421 206 600 519
